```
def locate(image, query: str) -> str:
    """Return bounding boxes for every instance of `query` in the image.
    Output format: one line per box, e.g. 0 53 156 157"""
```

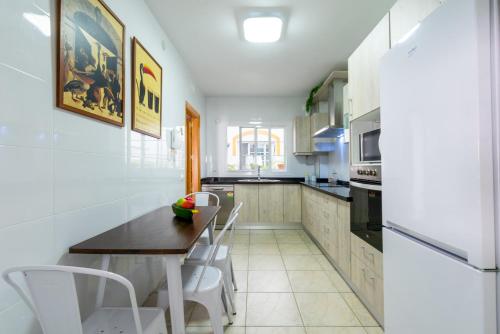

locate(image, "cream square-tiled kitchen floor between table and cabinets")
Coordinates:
145 230 383 334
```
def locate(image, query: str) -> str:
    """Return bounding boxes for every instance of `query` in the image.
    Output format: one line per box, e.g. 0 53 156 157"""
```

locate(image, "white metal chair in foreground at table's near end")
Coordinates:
2 265 167 334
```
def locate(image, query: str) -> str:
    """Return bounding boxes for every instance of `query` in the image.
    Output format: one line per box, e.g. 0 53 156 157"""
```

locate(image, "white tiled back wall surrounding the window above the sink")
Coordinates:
206 96 314 177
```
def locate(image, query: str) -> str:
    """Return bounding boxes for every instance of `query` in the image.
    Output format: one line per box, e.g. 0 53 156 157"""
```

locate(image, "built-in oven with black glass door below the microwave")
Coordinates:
350 165 383 252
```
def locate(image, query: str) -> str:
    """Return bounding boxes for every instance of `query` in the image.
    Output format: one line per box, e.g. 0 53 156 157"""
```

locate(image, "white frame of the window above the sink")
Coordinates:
225 124 288 173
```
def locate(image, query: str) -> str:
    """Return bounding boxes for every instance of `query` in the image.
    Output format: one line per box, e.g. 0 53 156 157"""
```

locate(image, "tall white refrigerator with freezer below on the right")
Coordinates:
380 0 500 334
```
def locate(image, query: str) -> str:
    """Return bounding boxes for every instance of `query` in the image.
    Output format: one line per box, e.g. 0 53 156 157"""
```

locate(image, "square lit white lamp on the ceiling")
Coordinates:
237 8 288 43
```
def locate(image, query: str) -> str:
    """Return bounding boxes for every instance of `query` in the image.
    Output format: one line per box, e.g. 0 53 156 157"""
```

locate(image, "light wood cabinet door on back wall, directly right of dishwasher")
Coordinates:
234 184 259 224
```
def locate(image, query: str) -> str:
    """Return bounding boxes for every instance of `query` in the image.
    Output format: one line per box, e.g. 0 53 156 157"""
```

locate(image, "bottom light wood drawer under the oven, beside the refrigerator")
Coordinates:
351 254 384 318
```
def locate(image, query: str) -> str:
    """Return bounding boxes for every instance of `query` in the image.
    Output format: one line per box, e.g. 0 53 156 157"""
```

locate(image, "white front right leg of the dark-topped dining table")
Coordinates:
165 254 186 334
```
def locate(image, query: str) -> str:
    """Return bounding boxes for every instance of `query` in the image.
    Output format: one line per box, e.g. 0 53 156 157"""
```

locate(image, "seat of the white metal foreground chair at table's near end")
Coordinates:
82 307 167 334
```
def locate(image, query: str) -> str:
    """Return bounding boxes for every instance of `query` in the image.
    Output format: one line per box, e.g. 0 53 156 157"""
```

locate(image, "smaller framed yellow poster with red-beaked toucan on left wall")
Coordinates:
132 38 163 139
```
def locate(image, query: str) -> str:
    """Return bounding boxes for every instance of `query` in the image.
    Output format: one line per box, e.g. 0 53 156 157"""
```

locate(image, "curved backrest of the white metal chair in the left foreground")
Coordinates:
2 265 142 334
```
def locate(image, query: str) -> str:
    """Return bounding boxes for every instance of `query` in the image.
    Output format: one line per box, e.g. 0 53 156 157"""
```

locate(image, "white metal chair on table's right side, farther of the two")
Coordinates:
184 203 243 314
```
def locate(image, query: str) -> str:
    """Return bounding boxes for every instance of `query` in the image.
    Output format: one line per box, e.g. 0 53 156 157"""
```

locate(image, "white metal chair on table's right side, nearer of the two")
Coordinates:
157 210 238 334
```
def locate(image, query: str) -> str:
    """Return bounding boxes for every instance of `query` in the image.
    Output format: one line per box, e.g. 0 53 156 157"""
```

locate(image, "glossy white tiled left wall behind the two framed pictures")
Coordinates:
0 0 205 334
